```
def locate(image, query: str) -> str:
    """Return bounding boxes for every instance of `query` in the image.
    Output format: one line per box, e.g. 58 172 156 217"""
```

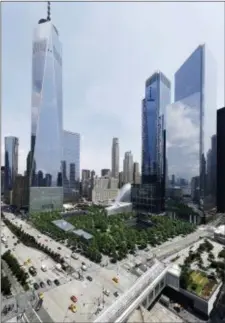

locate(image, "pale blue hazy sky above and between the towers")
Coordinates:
1 2 224 177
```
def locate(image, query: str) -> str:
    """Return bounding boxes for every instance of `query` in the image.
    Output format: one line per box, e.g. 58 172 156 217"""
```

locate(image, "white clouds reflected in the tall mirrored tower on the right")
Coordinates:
167 102 200 180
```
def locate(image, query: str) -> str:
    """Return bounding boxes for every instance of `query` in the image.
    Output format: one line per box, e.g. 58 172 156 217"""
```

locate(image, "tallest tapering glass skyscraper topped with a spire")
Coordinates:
28 3 63 213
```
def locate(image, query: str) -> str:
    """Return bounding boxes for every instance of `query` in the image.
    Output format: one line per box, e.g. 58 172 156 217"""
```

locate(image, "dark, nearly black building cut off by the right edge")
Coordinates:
216 107 225 213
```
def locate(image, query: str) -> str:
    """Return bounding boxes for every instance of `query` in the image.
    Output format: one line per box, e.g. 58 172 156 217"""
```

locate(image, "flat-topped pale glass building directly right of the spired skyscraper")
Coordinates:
62 130 80 202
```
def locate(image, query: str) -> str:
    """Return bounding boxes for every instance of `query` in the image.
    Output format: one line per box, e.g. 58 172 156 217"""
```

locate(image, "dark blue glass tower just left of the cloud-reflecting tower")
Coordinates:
141 72 171 213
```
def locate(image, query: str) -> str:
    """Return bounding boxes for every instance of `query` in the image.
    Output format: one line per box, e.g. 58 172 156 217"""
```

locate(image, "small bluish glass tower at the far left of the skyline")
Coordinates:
4 137 19 191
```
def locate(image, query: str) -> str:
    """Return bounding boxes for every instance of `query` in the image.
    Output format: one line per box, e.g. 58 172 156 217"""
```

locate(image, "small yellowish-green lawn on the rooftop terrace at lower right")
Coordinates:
187 271 217 298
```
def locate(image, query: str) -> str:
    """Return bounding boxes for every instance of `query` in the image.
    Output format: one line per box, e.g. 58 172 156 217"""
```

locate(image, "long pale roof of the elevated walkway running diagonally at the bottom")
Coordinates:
94 259 166 323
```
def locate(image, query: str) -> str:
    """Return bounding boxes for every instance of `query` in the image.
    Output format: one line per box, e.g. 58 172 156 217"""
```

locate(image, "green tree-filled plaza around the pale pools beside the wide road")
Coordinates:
30 208 196 263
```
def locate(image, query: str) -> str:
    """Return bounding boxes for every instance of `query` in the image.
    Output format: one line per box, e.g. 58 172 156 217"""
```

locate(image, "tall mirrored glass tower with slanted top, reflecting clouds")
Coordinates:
167 45 216 215
